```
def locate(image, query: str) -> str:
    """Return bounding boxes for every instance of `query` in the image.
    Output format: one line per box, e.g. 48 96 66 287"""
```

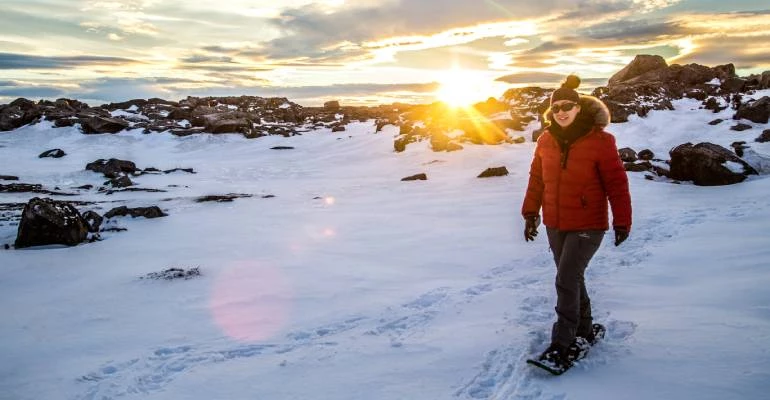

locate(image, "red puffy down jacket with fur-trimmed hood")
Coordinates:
521 96 631 231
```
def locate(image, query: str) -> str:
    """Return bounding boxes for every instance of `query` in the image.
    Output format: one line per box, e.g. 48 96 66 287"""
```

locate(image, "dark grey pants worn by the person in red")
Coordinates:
546 228 604 347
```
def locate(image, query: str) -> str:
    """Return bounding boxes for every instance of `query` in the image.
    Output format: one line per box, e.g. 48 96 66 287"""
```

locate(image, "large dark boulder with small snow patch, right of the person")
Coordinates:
669 143 757 186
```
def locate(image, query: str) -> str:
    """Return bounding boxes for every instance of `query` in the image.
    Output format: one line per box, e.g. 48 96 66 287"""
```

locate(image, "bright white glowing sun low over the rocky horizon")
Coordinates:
434 68 496 108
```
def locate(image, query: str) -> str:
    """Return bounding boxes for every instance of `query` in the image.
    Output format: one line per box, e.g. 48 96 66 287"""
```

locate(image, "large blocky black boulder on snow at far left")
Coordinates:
15 197 89 249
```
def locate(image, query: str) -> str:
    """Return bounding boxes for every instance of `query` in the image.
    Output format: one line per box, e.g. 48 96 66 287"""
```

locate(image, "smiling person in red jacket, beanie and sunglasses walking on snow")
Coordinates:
521 75 631 369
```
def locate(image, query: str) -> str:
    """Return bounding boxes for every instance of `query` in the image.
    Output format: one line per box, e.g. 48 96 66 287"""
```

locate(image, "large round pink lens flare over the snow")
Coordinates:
209 261 292 342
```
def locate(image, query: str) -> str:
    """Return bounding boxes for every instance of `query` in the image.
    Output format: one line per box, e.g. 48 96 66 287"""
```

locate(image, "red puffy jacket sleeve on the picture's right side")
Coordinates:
599 134 631 230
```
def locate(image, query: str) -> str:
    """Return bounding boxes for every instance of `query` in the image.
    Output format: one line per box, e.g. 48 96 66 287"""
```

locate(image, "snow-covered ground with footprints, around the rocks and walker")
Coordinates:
0 91 770 400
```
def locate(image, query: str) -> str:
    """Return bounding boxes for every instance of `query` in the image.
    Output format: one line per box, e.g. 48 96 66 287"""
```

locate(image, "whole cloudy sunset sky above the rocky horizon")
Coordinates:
0 0 770 105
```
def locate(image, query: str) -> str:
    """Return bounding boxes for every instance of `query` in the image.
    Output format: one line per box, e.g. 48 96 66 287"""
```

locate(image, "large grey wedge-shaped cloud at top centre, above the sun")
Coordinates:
263 0 593 60
